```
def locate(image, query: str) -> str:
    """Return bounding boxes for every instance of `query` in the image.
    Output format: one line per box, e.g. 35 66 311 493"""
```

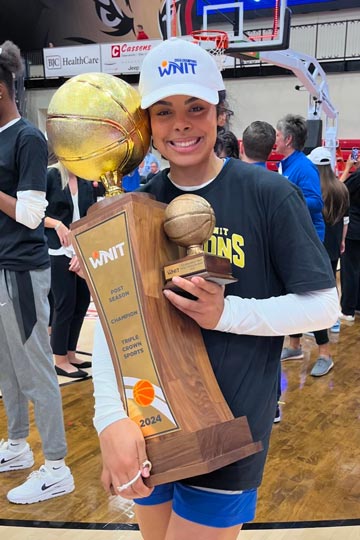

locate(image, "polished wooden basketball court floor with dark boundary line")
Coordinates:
0 314 360 540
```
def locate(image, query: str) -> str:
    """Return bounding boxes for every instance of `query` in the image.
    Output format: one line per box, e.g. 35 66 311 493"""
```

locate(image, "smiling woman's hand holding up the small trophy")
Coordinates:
164 276 224 330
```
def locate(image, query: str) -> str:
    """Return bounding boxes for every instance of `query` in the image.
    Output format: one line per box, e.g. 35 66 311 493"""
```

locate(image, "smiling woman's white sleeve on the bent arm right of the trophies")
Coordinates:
215 287 339 336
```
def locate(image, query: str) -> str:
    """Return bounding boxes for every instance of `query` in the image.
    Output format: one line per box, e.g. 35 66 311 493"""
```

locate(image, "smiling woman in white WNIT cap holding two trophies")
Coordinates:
93 39 338 540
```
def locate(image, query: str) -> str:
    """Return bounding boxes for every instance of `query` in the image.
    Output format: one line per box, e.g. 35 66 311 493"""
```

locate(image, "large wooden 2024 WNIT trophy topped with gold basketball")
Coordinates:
47 73 262 486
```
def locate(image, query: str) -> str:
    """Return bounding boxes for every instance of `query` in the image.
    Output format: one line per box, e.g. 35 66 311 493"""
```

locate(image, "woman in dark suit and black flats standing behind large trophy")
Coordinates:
45 163 96 378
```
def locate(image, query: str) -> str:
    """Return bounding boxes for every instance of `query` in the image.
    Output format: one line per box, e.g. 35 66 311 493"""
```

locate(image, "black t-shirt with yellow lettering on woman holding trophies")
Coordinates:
140 159 335 490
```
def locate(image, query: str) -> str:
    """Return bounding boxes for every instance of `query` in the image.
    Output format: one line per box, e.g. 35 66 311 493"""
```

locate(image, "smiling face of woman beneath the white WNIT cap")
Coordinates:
149 96 222 186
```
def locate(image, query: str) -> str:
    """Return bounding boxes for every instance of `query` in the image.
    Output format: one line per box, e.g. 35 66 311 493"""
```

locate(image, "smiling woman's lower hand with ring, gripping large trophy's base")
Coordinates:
99 418 152 499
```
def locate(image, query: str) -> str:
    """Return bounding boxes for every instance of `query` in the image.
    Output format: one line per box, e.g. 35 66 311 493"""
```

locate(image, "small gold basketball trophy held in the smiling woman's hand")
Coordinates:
163 194 237 293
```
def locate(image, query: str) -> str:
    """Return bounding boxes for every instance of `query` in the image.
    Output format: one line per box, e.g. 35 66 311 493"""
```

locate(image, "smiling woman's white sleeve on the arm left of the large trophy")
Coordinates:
92 320 127 433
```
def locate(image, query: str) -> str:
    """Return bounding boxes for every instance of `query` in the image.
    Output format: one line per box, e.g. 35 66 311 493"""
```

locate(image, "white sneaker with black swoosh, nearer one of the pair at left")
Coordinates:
7 465 75 504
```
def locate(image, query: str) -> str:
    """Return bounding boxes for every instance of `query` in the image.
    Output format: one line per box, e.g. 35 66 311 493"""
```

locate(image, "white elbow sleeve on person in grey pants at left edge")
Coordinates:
15 189 48 229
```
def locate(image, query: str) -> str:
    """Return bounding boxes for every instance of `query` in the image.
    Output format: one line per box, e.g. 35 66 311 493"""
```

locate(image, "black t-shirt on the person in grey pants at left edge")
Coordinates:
0 118 50 271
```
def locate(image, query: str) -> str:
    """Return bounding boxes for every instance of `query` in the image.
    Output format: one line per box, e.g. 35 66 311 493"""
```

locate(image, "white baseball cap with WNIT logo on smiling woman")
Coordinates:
139 38 225 109
